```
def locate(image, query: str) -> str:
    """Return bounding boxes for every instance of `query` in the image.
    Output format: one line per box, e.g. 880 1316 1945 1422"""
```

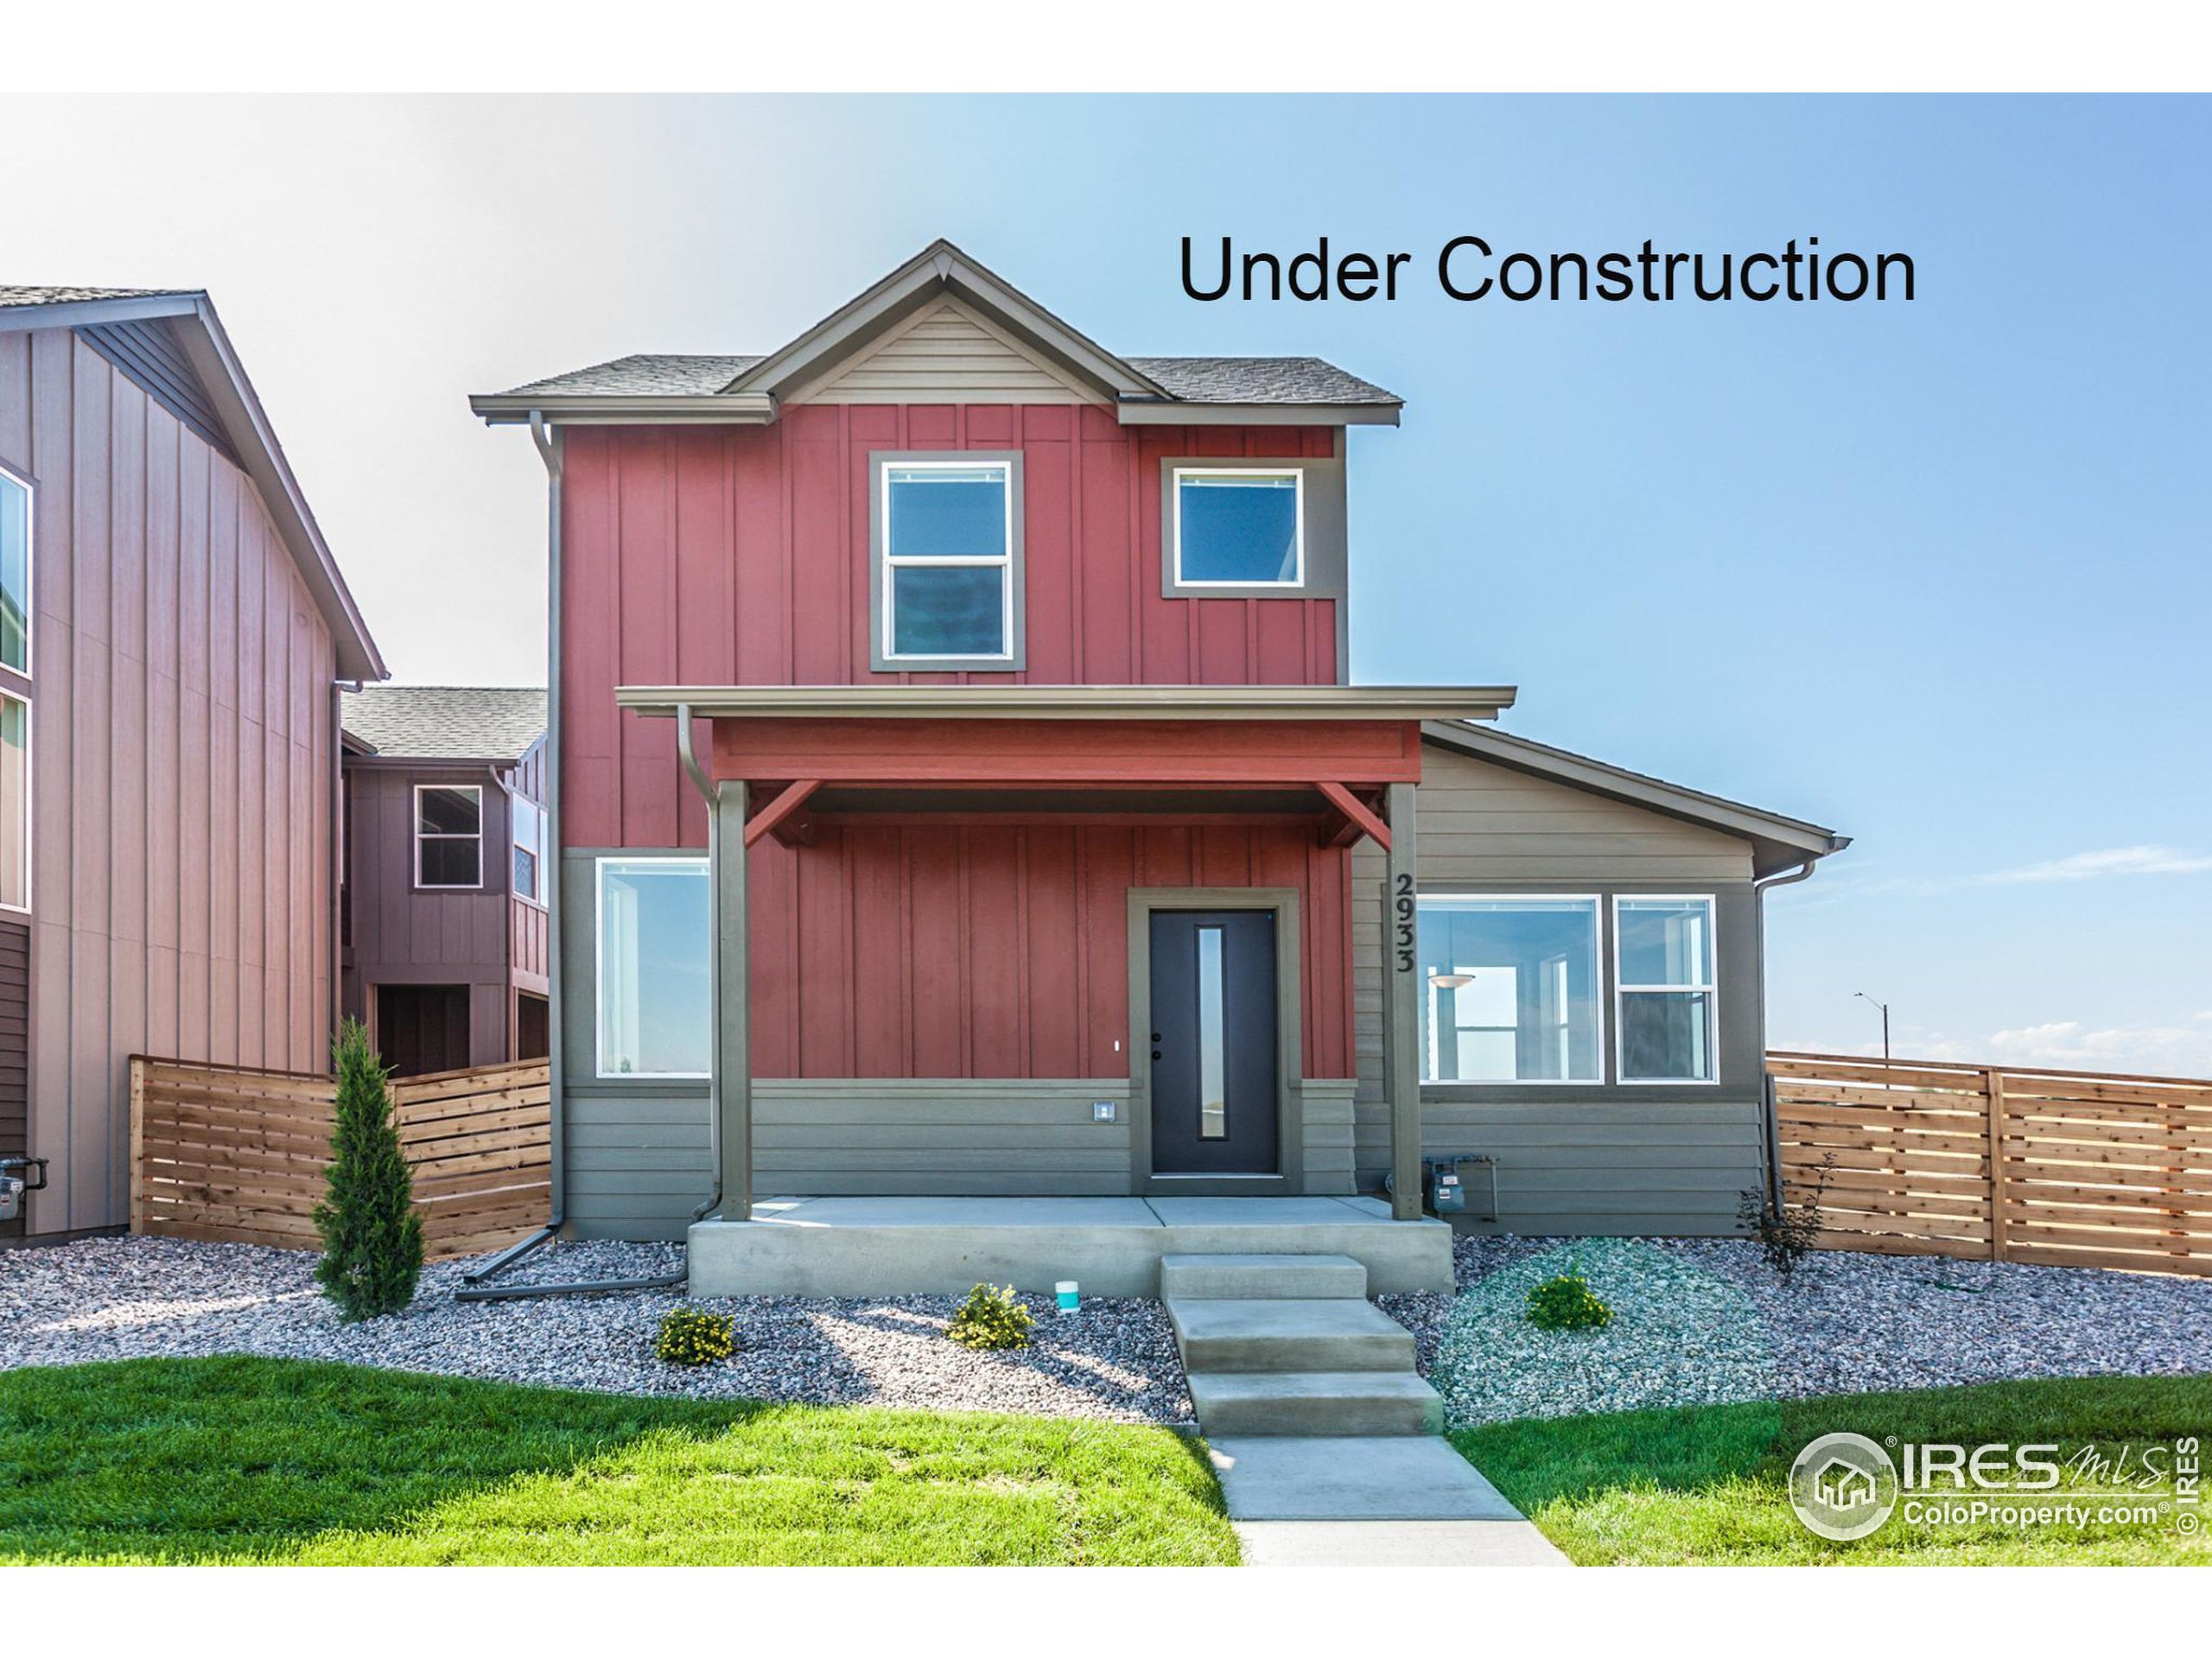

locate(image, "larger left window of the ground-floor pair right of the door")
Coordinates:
1418 893 1604 1084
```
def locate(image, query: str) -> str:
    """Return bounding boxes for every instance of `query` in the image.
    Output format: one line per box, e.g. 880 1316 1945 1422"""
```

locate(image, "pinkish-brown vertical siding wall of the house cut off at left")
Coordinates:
0 329 336 1232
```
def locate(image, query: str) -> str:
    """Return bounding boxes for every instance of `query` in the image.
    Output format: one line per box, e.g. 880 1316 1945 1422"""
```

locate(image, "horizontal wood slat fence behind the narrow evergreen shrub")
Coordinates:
130 1055 553 1259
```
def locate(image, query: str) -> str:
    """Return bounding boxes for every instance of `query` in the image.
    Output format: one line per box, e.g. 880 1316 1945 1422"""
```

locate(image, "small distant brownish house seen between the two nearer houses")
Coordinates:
339 686 550 1077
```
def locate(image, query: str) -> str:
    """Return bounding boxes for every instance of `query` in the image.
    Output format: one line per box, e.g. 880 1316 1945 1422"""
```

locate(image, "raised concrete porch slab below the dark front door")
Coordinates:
688 1197 1451 1296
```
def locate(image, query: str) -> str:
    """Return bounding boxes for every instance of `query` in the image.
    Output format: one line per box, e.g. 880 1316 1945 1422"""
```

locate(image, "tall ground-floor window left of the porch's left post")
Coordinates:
597 858 715 1077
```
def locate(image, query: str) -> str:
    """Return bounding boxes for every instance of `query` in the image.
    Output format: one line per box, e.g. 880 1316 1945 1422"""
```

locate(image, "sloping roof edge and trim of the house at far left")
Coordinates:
0 285 391 679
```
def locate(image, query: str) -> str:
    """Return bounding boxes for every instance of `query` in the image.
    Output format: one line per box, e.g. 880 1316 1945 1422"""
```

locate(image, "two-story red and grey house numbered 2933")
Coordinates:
474 244 1842 1236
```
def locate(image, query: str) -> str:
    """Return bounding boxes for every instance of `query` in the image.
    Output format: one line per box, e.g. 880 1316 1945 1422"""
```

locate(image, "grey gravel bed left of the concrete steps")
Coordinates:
0 1236 1190 1422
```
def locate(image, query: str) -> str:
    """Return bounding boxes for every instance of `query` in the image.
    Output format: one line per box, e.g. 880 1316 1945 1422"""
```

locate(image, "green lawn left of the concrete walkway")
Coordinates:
0 1358 1236 1566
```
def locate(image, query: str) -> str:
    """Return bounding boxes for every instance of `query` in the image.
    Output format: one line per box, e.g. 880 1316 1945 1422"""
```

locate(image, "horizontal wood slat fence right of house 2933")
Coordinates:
1767 1053 2212 1274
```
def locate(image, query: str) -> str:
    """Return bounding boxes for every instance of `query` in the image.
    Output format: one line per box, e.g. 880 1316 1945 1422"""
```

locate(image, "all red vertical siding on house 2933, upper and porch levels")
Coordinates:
560 404 1351 1092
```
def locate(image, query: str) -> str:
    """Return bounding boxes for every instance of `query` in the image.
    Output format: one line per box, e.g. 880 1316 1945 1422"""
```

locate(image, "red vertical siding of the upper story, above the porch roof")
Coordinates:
562 404 1338 847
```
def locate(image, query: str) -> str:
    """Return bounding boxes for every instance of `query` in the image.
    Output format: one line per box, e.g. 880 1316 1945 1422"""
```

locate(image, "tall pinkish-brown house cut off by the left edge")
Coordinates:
0 288 385 1234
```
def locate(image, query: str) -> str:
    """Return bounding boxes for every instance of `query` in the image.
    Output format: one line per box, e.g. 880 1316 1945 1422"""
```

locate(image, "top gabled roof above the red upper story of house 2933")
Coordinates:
469 238 1402 435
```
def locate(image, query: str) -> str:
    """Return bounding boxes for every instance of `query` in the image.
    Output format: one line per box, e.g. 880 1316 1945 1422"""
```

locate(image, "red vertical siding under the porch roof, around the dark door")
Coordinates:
747 823 1351 1077
